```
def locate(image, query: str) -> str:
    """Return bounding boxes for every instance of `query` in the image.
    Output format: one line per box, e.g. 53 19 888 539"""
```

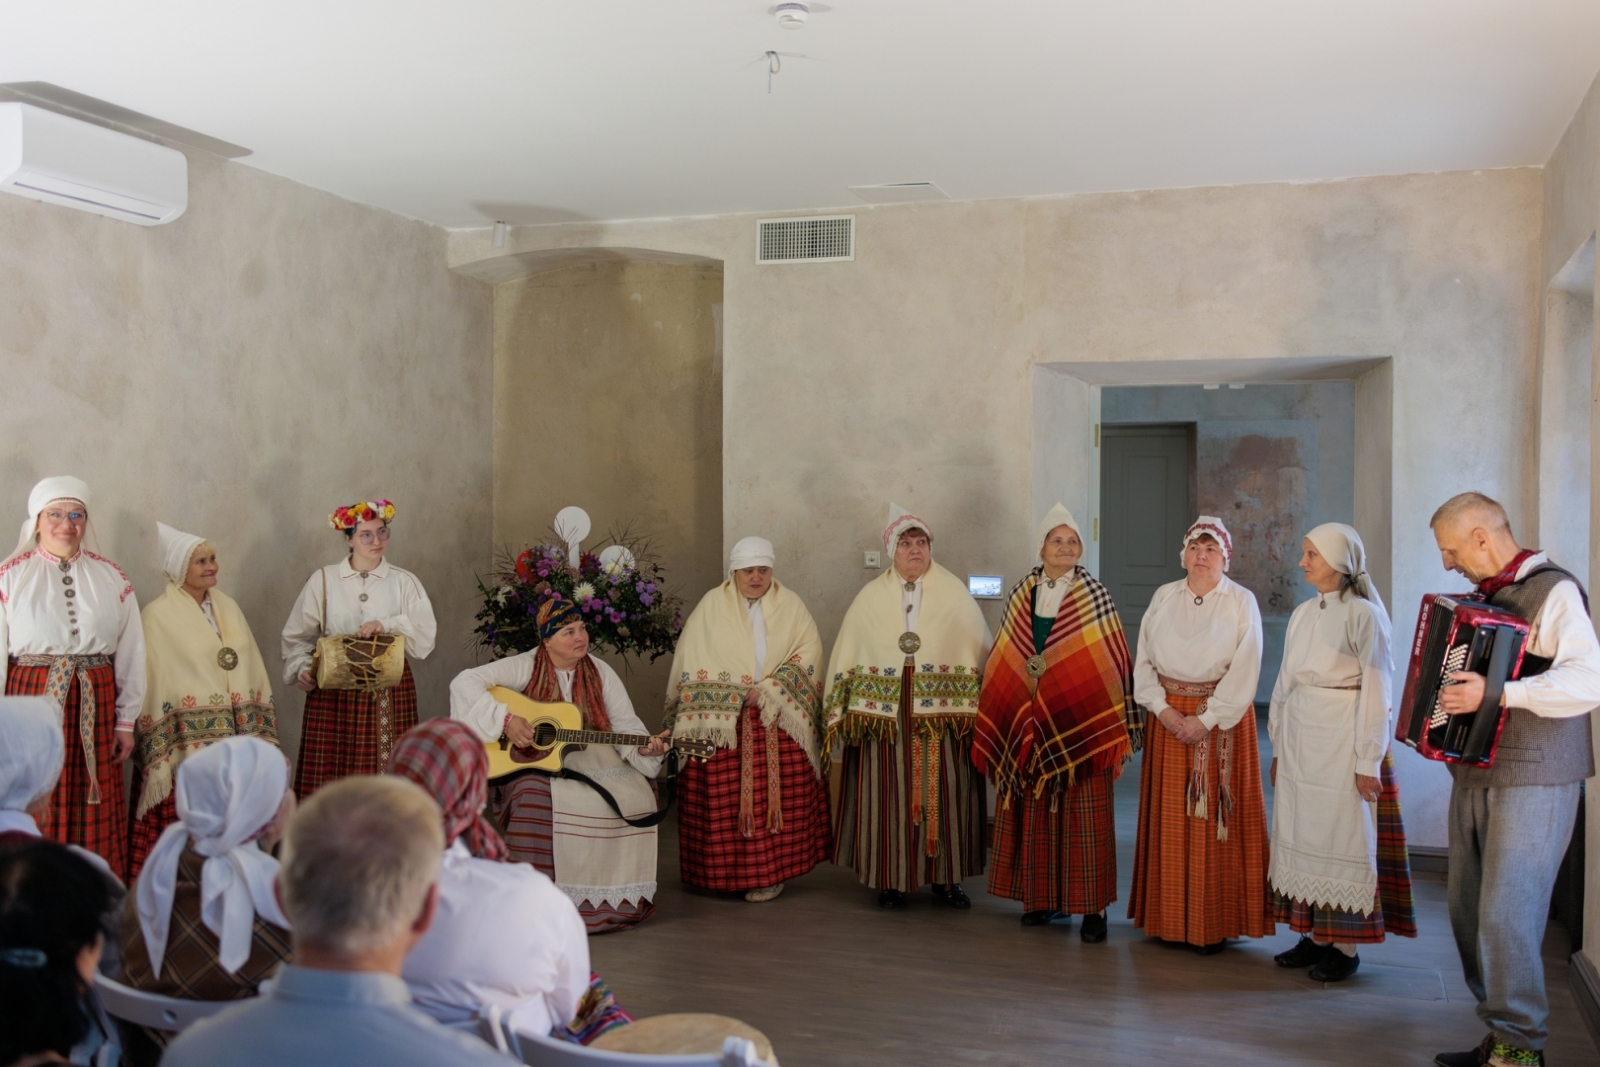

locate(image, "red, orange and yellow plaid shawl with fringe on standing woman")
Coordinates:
973 566 1133 797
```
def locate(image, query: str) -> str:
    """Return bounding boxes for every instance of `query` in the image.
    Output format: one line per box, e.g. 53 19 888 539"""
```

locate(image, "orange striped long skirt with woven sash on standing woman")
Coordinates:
1128 678 1274 945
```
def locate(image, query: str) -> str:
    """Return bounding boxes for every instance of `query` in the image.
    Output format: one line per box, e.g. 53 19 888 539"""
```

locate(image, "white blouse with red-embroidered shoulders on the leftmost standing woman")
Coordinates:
0 547 144 729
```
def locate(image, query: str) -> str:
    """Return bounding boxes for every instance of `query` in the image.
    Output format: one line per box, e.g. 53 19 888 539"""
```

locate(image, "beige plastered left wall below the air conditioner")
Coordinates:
0 154 493 764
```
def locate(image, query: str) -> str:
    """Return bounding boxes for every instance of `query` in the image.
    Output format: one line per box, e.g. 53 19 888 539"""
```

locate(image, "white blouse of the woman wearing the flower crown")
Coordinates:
283 560 438 683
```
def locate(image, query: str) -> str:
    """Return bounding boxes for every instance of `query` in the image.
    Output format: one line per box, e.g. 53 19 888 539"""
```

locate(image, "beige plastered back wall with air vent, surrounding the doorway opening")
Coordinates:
451 168 1542 845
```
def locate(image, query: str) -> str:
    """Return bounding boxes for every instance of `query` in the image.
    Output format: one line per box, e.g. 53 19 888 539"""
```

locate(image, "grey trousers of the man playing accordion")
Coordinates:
1450 782 1579 1051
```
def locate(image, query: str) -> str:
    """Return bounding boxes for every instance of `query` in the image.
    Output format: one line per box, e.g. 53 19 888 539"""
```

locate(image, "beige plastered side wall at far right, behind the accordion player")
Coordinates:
1539 66 1600 966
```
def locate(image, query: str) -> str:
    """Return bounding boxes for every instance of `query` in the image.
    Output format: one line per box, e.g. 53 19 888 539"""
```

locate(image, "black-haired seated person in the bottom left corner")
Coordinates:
0 838 118 1067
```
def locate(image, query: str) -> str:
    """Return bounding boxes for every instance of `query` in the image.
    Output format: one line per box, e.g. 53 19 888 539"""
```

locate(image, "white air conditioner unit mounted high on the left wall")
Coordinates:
0 102 189 226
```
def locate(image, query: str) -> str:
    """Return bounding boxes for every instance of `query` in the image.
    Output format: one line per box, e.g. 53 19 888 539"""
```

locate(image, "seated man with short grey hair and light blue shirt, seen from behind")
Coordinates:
162 776 514 1067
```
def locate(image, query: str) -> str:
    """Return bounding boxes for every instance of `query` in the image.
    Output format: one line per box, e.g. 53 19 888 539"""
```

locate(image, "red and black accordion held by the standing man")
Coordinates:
1395 593 1528 766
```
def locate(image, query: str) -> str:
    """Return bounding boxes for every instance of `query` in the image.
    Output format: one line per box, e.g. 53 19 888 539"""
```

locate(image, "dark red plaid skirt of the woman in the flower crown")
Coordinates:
294 664 416 800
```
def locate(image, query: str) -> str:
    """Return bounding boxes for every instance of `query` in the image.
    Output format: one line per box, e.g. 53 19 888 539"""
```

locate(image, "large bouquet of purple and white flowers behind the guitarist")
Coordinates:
474 530 683 661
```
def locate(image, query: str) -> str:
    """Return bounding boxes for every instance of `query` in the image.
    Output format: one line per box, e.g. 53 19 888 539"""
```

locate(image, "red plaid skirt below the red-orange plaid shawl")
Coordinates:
989 768 1117 915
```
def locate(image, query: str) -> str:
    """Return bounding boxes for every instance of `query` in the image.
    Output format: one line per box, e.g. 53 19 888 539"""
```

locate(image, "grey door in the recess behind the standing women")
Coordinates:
1099 422 1195 654
